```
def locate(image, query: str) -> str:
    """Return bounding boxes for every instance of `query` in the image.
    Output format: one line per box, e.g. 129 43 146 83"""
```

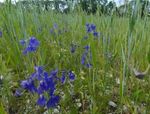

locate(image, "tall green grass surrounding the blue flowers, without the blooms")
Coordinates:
0 1 150 114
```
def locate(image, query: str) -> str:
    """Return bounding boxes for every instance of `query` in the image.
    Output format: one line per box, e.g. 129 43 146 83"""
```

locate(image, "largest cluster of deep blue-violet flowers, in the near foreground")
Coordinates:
16 66 75 108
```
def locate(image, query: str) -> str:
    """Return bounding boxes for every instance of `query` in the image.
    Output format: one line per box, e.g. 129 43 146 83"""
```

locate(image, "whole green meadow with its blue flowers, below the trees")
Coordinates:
0 2 150 114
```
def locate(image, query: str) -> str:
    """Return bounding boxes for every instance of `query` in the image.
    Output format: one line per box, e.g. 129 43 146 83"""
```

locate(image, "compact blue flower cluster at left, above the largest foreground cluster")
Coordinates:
20 37 40 55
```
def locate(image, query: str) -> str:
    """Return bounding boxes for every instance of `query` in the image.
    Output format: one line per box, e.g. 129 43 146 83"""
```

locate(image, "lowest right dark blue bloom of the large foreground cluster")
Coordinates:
47 96 60 108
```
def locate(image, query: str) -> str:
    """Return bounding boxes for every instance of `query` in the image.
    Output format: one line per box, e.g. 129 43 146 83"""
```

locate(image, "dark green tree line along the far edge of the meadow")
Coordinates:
12 0 150 17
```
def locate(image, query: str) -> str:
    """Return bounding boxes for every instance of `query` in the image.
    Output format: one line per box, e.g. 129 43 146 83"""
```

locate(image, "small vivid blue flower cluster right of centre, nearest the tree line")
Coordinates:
86 23 99 37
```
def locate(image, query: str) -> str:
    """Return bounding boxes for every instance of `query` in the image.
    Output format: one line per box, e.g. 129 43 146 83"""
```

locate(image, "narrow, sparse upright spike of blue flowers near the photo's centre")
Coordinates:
81 45 92 68
